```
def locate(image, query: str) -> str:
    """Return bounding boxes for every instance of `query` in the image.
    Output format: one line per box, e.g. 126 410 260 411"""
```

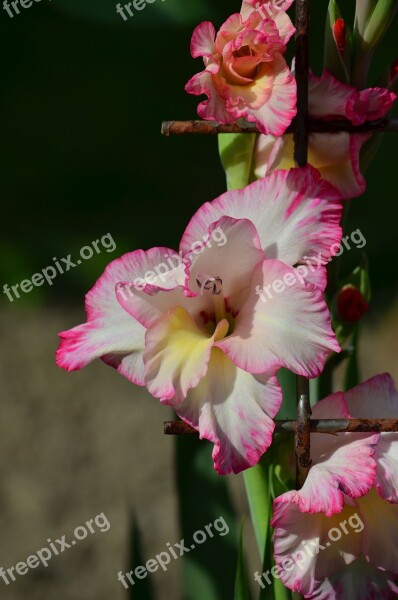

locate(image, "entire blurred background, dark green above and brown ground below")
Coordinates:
0 0 398 600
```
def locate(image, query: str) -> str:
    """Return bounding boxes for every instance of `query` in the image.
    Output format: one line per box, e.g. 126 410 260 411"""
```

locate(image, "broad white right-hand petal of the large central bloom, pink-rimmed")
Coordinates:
216 260 340 377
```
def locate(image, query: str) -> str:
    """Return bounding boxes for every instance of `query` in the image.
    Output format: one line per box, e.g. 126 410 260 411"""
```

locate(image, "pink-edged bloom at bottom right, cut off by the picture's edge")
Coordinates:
273 374 398 600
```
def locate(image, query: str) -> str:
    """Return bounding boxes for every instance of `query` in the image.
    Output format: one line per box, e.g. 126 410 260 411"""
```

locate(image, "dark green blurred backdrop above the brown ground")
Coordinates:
0 0 398 307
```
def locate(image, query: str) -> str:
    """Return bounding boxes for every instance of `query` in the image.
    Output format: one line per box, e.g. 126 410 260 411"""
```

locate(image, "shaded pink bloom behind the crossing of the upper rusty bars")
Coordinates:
254 71 396 198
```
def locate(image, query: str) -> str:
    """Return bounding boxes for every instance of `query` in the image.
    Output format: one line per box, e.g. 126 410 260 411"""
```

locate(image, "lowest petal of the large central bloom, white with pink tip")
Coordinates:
176 348 282 475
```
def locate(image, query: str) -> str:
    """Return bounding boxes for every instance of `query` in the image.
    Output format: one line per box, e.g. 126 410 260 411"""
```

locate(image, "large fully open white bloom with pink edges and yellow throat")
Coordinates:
57 166 342 474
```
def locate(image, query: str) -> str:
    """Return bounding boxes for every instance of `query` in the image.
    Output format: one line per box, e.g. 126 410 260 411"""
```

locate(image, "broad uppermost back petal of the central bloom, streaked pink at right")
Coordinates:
180 166 342 265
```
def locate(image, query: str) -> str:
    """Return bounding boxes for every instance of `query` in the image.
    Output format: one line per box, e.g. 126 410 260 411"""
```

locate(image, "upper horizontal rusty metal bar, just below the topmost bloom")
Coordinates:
161 117 398 136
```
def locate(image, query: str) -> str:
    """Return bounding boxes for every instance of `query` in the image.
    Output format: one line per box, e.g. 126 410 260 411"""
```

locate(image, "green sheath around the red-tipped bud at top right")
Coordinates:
323 0 352 83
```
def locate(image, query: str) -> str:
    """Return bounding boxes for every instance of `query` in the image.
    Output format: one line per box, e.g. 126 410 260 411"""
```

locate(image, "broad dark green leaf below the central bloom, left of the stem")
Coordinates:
176 436 238 600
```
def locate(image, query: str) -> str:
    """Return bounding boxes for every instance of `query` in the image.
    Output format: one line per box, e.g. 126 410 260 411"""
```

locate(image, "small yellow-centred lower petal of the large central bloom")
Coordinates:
144 306 229 401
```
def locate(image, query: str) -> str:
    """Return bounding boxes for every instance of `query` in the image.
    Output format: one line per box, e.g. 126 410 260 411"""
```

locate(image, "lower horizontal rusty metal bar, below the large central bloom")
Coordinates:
164 419 398 435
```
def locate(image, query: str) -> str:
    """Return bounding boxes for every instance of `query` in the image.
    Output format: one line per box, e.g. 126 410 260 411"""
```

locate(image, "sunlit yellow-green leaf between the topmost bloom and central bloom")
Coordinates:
218 133 256 190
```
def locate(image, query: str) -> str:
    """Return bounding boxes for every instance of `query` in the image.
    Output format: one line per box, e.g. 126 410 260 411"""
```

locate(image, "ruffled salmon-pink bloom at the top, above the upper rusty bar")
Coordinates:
185 10 296 135
